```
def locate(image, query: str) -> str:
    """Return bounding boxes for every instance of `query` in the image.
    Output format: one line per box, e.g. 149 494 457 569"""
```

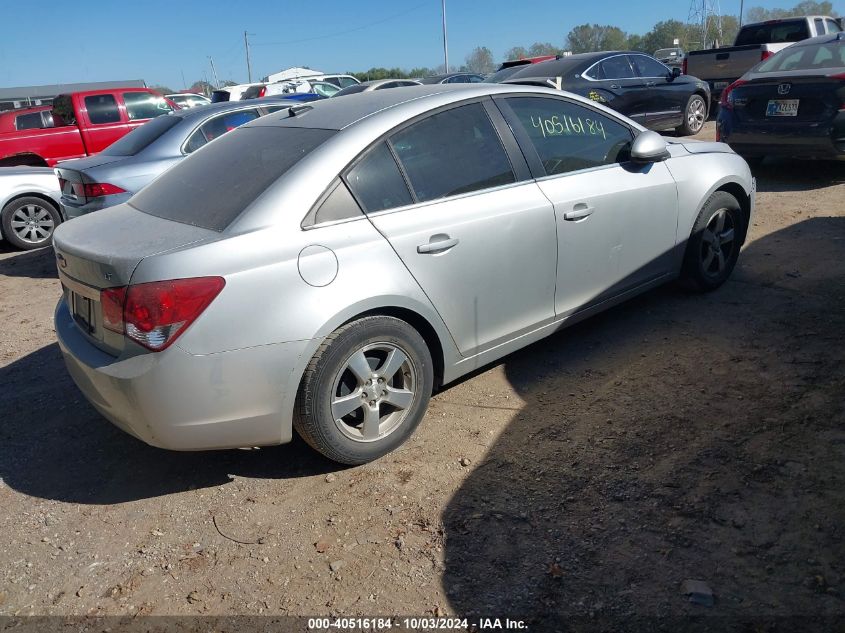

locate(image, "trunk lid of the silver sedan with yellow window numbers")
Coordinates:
53 205 223 356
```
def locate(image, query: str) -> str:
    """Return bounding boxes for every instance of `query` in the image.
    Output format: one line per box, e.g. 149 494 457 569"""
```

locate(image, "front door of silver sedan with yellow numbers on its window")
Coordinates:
496 96 678 317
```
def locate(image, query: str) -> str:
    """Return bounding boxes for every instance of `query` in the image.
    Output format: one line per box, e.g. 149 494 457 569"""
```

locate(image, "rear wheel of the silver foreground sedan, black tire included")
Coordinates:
293 316 434 465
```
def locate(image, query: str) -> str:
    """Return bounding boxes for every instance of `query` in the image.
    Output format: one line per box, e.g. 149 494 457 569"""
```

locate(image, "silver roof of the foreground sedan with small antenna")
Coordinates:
247 83 616 130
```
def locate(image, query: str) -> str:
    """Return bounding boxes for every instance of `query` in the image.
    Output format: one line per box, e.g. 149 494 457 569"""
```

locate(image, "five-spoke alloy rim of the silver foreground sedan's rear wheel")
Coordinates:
331 342 418 442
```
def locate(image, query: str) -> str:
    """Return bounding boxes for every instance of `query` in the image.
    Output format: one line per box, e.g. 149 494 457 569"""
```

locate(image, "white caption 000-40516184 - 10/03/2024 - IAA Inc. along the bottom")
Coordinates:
308 617 528 631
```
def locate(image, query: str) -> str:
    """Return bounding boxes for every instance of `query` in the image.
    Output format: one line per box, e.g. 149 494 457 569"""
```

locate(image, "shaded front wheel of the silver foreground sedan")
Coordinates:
681 191 746 292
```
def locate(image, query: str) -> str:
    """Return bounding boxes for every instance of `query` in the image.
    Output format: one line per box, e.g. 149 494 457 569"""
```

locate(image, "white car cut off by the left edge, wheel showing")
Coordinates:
0 167 62 250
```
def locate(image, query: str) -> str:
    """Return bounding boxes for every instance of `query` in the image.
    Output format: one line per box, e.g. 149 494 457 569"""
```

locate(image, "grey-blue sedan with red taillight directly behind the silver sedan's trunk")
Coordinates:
55 98 296 218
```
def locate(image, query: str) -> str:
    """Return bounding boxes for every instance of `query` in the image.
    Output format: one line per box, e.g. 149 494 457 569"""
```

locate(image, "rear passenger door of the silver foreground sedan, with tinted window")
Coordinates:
346 100 557 356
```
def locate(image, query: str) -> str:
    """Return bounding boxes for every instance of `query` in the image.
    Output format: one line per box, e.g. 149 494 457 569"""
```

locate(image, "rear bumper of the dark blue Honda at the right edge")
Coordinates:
717 112 845 159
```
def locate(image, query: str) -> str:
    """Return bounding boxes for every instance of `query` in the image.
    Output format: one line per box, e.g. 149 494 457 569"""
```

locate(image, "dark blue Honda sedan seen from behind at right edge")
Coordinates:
716 33 845 162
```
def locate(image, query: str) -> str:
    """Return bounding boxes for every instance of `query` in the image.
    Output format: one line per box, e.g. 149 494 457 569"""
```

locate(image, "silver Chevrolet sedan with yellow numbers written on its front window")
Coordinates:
54 84 755 464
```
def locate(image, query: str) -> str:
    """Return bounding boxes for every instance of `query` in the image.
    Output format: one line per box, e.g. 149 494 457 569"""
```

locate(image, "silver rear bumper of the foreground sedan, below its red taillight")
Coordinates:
55 300 308 450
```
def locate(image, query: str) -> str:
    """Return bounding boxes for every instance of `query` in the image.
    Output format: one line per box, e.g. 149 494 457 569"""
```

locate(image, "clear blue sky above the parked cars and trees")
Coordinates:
0 0 820 89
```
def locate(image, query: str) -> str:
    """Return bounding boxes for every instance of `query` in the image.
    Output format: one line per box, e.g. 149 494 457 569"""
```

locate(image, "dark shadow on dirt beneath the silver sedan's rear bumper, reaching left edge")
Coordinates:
0 343 341 504
